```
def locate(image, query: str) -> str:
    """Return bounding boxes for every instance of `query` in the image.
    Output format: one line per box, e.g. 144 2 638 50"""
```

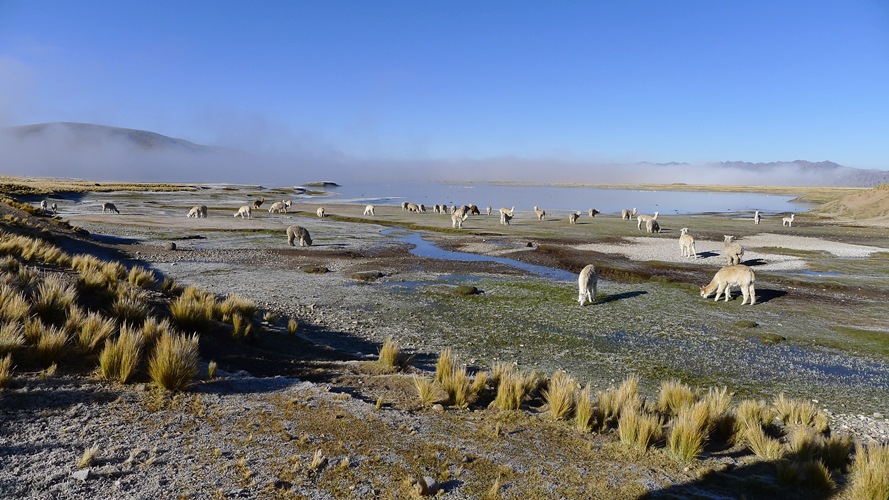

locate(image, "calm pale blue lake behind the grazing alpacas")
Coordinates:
308 182 815 214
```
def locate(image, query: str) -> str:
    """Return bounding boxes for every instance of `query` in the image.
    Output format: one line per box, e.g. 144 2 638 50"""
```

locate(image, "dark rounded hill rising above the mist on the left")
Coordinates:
5 122 225 154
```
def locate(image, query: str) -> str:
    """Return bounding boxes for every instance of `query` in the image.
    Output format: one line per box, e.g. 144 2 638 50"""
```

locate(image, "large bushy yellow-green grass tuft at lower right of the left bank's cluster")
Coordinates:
148 331 198 391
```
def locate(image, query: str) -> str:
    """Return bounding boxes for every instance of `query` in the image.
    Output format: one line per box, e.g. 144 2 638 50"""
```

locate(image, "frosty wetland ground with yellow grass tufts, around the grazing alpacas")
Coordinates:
0 181 889 498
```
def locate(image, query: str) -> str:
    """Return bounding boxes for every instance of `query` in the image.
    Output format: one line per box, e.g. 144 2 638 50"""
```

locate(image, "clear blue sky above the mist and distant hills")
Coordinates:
0 0 889 169
